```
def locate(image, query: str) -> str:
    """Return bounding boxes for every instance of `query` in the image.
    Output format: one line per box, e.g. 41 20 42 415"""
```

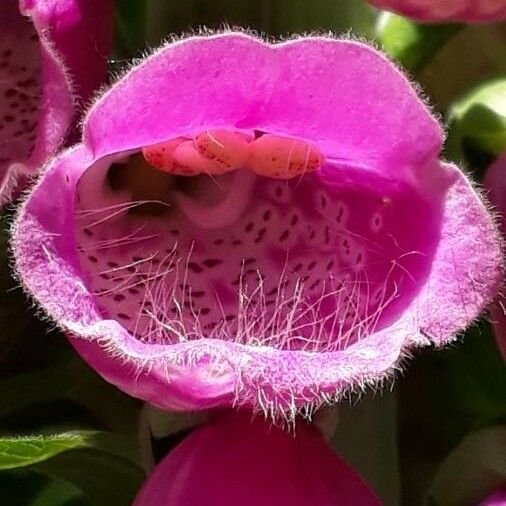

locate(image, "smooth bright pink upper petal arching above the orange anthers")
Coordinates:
84 33 442 171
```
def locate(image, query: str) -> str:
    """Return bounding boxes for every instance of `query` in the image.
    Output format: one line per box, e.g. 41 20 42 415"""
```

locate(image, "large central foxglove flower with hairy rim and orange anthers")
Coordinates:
13 33 500 419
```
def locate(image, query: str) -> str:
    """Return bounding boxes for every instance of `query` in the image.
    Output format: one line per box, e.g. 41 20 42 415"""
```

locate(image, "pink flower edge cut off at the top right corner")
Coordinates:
369 0 506 23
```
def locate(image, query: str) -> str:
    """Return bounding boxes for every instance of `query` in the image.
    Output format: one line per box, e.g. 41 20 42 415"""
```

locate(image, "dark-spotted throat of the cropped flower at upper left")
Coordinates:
0 1 41 187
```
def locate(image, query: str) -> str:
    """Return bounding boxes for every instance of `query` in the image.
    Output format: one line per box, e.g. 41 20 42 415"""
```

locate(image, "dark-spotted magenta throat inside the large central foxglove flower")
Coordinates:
75 130 442 352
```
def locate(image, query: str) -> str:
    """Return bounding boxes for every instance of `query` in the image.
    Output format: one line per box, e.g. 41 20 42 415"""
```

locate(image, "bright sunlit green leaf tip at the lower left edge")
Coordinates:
0 432 88 469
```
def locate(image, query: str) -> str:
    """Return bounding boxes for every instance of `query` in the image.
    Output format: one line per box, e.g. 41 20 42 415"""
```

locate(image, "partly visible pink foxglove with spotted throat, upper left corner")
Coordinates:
0 0 113 204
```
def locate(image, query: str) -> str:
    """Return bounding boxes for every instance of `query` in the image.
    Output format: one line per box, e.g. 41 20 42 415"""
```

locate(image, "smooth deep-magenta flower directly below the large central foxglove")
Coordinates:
134 412 381 506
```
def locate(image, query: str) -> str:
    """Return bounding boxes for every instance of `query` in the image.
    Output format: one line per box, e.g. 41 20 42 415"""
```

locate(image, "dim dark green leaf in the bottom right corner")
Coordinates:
428 425 506 506
